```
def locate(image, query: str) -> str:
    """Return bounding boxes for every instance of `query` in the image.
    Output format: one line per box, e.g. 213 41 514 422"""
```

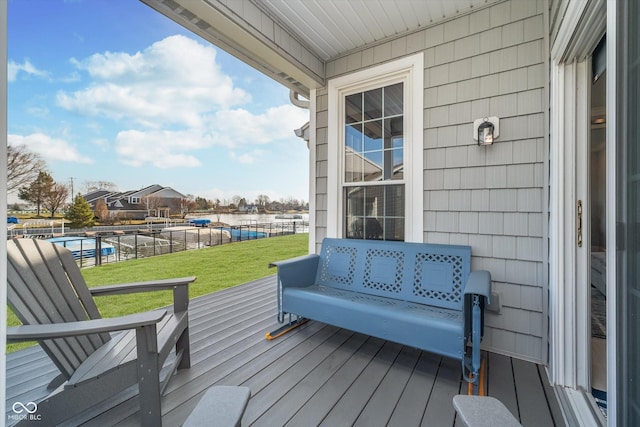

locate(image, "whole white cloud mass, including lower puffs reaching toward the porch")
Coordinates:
51 36 309 169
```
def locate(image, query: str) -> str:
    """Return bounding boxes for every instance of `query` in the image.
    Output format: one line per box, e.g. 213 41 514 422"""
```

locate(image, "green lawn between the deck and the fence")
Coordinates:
7 234 309 352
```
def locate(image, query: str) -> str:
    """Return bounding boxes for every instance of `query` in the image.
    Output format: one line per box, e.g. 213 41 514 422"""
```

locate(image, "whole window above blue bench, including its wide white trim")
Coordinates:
327 54 424 242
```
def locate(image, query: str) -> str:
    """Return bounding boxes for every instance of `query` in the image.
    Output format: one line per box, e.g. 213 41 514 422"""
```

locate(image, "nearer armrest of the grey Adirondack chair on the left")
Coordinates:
7 310 167 342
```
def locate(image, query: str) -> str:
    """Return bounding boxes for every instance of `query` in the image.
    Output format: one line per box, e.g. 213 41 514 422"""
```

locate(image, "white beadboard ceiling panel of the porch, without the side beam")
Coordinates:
251 0 497 61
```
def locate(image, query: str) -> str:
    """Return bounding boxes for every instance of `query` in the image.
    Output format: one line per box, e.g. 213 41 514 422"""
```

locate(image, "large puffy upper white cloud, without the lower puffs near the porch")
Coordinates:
57 35 251 128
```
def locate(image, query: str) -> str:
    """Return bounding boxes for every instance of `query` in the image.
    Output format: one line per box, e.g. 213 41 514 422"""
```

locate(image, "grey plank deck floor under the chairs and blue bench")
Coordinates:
7 276 564 427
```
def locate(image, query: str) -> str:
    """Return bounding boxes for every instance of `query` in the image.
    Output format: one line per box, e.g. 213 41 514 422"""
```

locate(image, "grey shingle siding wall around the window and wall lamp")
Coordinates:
316 1 548 361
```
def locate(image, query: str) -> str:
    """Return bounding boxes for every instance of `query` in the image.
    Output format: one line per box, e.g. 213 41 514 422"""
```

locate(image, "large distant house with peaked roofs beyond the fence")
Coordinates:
82 184 186 219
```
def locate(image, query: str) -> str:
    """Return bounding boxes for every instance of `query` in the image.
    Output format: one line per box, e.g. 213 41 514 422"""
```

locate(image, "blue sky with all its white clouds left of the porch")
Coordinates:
8 0 309 206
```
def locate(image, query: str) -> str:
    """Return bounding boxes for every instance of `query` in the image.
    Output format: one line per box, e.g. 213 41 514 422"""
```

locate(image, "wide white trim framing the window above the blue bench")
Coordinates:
327 53 424 242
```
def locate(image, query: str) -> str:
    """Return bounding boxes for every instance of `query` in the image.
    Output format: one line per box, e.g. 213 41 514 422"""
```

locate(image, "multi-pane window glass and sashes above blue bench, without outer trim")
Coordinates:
343 83 405 240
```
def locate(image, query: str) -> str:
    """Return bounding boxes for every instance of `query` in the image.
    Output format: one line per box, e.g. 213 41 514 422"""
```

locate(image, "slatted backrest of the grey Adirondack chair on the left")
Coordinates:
7 239 110 378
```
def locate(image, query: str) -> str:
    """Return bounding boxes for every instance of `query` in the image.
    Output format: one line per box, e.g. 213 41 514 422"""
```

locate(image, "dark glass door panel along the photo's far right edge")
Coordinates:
613 1 640 426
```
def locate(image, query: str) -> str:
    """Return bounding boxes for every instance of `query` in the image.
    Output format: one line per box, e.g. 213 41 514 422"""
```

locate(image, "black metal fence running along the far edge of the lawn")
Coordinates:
13 221 308 267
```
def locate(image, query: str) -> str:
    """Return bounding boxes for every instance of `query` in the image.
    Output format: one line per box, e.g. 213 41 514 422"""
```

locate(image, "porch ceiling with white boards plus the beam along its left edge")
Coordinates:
141 0 502 96
